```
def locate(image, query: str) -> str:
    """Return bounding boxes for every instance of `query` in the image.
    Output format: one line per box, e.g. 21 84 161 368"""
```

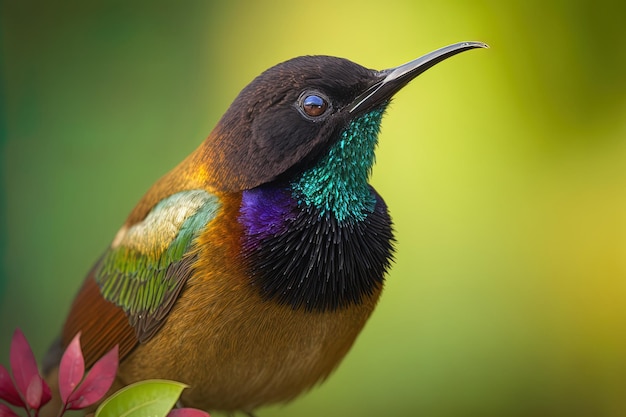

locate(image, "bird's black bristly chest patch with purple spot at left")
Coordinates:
238 184 393 311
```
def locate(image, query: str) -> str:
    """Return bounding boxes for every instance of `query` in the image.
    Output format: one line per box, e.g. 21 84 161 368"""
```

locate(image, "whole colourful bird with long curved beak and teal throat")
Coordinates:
45 42 487 414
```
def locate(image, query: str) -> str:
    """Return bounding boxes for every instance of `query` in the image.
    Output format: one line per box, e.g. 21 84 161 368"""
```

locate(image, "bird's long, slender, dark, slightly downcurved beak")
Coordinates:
348 42 489 113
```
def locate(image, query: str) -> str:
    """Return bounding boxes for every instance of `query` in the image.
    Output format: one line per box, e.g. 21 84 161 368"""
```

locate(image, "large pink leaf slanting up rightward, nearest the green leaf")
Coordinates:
67 345 118 410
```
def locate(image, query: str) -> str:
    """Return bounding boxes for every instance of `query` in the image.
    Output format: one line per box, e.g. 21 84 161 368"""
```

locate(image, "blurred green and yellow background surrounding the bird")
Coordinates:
0 0 626 417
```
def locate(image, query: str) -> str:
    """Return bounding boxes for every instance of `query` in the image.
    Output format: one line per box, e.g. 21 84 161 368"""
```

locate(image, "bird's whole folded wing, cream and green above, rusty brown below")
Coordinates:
63 190 221 364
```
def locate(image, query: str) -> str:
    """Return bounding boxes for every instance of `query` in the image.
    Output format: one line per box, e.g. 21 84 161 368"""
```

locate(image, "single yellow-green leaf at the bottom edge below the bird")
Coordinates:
96 379 187 417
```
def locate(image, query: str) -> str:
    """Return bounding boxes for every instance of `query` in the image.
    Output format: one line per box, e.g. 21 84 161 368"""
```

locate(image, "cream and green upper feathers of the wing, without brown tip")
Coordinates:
95 190 221 342
